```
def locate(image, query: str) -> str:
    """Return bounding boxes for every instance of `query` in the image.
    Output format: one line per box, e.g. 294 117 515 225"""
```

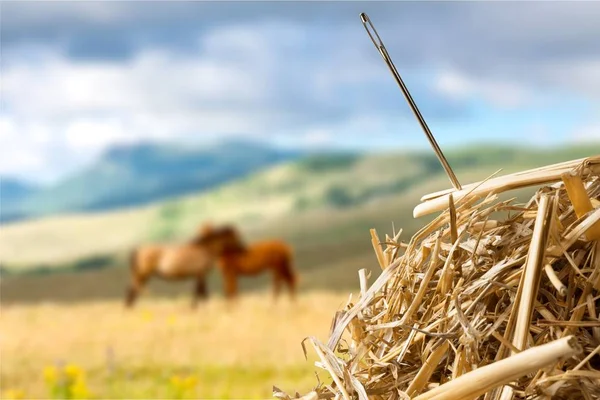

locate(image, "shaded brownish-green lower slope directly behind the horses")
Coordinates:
0 170 526 304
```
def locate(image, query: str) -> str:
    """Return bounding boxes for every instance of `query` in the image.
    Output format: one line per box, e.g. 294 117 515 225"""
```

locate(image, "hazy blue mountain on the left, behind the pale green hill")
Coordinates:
0 141 300 222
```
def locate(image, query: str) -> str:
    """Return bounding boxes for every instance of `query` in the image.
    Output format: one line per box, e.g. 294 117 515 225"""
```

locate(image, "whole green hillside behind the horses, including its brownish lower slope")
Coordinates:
0 146 594 299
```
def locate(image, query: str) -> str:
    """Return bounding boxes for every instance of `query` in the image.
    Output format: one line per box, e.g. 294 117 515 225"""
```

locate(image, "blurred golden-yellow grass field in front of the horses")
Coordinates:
0 292 347 399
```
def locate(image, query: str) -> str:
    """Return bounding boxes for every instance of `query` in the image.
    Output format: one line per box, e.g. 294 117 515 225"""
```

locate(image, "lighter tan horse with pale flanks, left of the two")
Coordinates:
125 224 225 308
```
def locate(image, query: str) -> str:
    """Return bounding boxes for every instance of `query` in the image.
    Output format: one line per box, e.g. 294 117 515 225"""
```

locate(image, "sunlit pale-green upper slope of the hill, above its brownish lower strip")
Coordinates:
0 142 594 269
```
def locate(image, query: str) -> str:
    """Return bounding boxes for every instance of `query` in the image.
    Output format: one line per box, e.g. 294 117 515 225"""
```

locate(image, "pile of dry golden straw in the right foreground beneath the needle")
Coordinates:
274 156 600 400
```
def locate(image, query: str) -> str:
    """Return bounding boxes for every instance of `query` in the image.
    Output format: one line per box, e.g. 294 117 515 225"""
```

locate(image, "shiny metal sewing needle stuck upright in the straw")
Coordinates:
360 13 462 190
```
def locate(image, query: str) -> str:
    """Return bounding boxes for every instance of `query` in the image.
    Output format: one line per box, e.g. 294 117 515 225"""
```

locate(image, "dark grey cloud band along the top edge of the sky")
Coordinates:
2 1 600 72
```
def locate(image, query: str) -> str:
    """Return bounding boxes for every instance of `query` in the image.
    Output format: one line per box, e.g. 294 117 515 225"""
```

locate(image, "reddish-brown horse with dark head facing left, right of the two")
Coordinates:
199 225 298 299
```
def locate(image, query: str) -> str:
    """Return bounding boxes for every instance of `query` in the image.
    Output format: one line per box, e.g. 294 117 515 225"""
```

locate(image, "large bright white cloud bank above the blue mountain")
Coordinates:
0 24 385 179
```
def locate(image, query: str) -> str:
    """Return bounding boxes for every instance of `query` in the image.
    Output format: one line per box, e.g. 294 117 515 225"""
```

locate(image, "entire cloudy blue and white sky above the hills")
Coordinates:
0 1 600 182
